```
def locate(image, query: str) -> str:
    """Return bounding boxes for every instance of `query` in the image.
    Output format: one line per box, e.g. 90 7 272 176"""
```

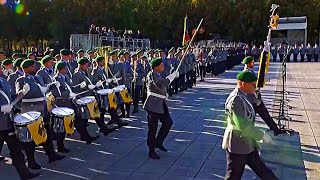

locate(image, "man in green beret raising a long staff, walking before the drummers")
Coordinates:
143 58 178 159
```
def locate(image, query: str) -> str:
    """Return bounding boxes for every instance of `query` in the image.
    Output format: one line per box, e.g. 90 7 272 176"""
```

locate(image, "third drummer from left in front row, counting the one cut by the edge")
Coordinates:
51 61 99 144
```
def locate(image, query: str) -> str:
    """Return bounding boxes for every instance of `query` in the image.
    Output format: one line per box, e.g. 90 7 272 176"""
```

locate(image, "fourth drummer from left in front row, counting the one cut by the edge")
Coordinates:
71 58 113 136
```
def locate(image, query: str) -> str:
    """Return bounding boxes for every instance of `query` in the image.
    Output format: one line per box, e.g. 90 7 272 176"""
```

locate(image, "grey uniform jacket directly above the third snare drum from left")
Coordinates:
71 70 94 97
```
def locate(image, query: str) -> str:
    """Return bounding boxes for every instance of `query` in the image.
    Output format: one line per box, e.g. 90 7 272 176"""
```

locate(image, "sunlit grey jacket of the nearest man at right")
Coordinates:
222 87 263 154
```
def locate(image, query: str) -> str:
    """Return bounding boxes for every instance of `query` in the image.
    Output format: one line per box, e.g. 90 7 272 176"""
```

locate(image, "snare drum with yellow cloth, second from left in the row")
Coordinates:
51 107 74 135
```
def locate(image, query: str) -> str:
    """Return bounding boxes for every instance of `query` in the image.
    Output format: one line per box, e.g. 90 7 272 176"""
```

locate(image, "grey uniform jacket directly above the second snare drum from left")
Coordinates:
50 73 72 108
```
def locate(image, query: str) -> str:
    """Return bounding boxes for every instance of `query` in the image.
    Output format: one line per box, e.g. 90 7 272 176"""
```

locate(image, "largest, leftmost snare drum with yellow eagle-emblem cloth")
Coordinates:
13 111 47 145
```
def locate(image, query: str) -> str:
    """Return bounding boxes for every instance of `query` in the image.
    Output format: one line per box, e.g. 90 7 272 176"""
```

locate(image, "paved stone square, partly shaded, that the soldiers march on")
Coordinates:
0 61 320 180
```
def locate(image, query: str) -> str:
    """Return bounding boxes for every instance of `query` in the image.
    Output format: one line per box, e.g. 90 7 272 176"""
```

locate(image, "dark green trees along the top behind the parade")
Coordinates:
0 0 320 45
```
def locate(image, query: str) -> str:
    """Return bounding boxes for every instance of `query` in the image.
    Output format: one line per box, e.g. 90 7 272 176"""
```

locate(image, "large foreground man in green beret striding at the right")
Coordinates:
222 71 278 180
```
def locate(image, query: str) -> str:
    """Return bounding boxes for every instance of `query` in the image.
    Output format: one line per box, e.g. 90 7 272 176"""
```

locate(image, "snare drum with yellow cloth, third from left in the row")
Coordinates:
76 96 100 119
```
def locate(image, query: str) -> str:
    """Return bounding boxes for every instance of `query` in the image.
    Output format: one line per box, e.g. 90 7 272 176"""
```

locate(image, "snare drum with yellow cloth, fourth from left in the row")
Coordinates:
97 89 117 109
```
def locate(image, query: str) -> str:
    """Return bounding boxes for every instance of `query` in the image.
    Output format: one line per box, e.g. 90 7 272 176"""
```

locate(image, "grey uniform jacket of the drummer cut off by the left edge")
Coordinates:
0 78 13 131
